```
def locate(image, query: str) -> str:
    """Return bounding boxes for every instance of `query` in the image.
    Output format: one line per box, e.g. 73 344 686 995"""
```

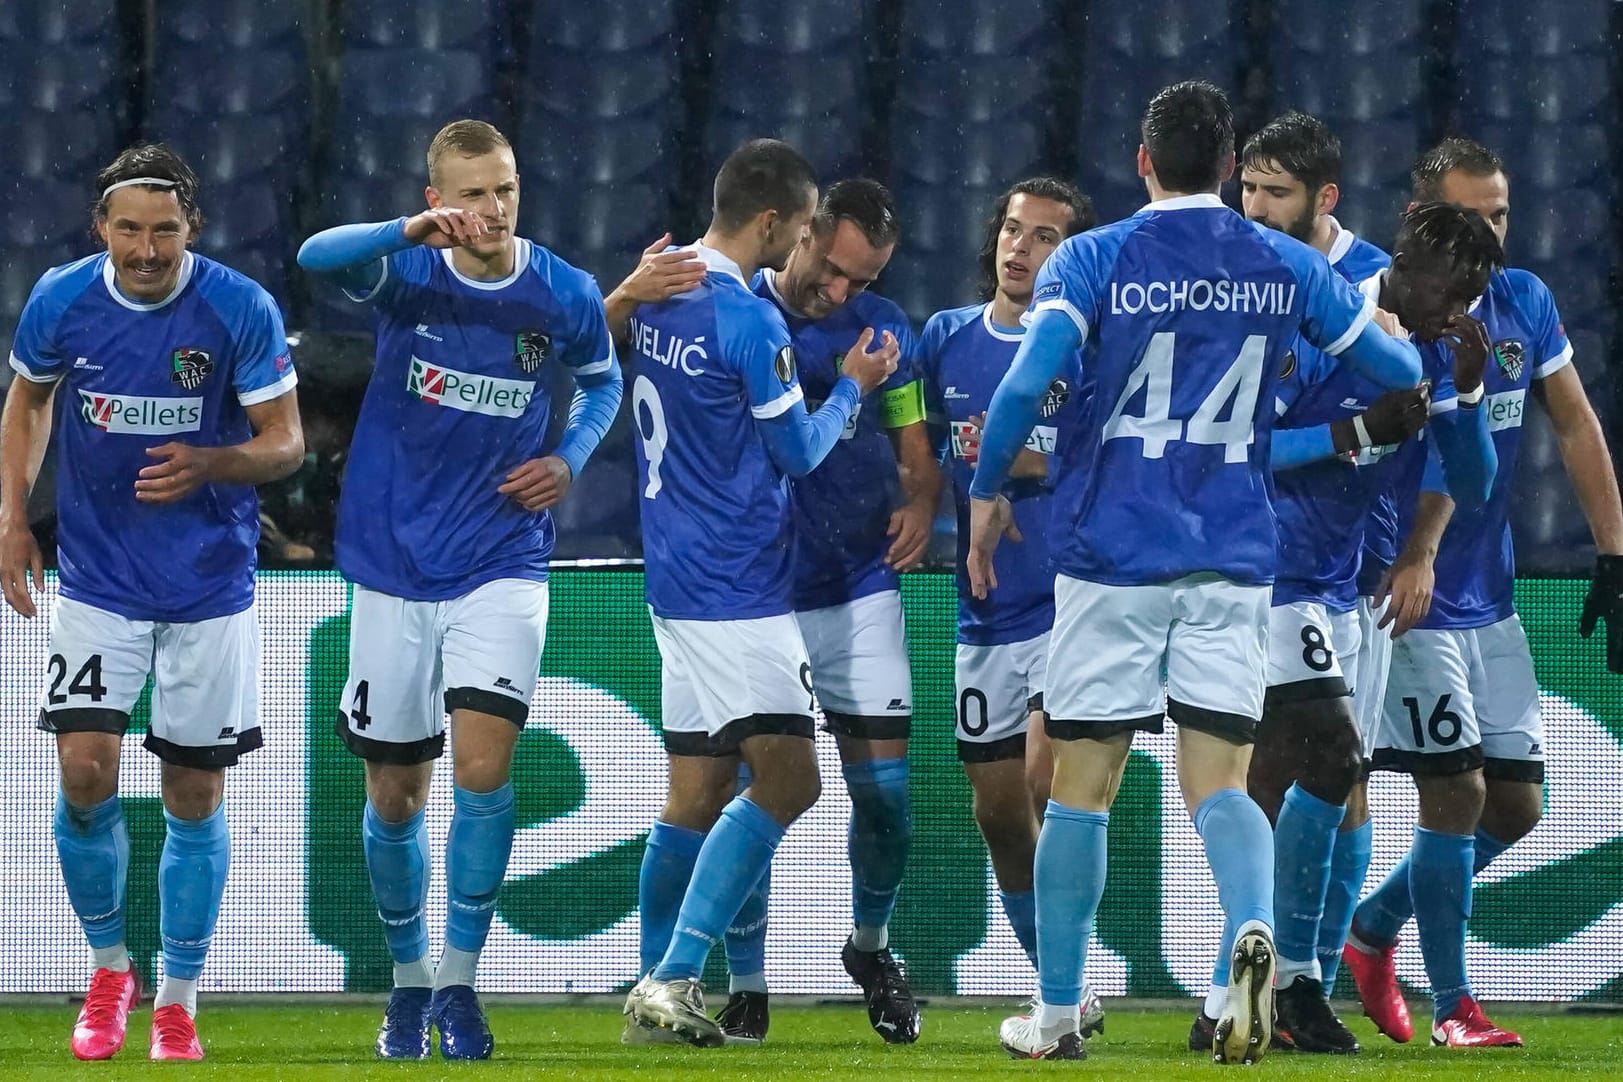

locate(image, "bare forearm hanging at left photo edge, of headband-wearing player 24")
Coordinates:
0 376 57 616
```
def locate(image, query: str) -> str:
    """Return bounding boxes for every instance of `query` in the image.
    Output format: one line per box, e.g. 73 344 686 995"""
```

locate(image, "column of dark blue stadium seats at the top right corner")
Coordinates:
1453 0 1620 558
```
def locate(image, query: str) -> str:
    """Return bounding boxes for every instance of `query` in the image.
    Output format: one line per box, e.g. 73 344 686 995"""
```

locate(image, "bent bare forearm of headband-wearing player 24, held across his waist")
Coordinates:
135 391 304 503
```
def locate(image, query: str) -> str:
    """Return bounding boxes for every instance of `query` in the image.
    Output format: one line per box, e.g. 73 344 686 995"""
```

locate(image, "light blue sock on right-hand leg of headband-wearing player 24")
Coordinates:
157 805 230 981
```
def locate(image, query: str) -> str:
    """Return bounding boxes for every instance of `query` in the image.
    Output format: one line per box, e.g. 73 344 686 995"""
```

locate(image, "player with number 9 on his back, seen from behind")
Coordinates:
625 140 898 1046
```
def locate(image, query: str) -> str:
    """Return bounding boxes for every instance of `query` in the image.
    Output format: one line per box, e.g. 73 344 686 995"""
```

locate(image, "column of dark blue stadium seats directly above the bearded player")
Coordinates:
1269 0 1430 238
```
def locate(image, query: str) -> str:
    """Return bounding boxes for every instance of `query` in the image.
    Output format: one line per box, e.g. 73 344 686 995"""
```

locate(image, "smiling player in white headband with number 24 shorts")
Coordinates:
0 144 304 1059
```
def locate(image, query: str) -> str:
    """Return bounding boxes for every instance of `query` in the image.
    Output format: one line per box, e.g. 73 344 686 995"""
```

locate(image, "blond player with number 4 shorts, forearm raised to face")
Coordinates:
299 120 622 1059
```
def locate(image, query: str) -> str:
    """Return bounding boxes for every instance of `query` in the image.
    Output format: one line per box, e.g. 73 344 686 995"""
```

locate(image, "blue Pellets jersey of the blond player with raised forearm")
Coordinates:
334 238 615 600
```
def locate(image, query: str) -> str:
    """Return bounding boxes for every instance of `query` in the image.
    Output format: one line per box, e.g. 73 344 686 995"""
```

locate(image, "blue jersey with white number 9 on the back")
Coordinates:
630 245 805 620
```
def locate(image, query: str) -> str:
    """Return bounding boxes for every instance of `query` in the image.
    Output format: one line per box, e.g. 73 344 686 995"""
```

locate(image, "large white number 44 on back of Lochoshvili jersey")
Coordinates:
1104 331 1268 462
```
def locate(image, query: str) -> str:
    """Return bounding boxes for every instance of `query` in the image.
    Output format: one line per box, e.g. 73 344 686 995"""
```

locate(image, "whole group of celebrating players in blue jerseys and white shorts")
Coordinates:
0 83 1623 1064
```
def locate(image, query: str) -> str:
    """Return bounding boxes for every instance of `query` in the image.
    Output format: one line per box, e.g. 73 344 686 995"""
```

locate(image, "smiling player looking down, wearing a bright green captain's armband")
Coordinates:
719 178 941 1043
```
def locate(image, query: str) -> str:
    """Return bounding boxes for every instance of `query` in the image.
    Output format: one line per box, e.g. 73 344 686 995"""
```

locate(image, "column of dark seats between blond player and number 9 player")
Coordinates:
516 0 687 290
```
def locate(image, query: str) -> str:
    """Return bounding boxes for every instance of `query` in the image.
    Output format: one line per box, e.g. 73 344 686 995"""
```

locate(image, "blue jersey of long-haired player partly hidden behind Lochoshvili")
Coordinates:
920 303 1079 646
